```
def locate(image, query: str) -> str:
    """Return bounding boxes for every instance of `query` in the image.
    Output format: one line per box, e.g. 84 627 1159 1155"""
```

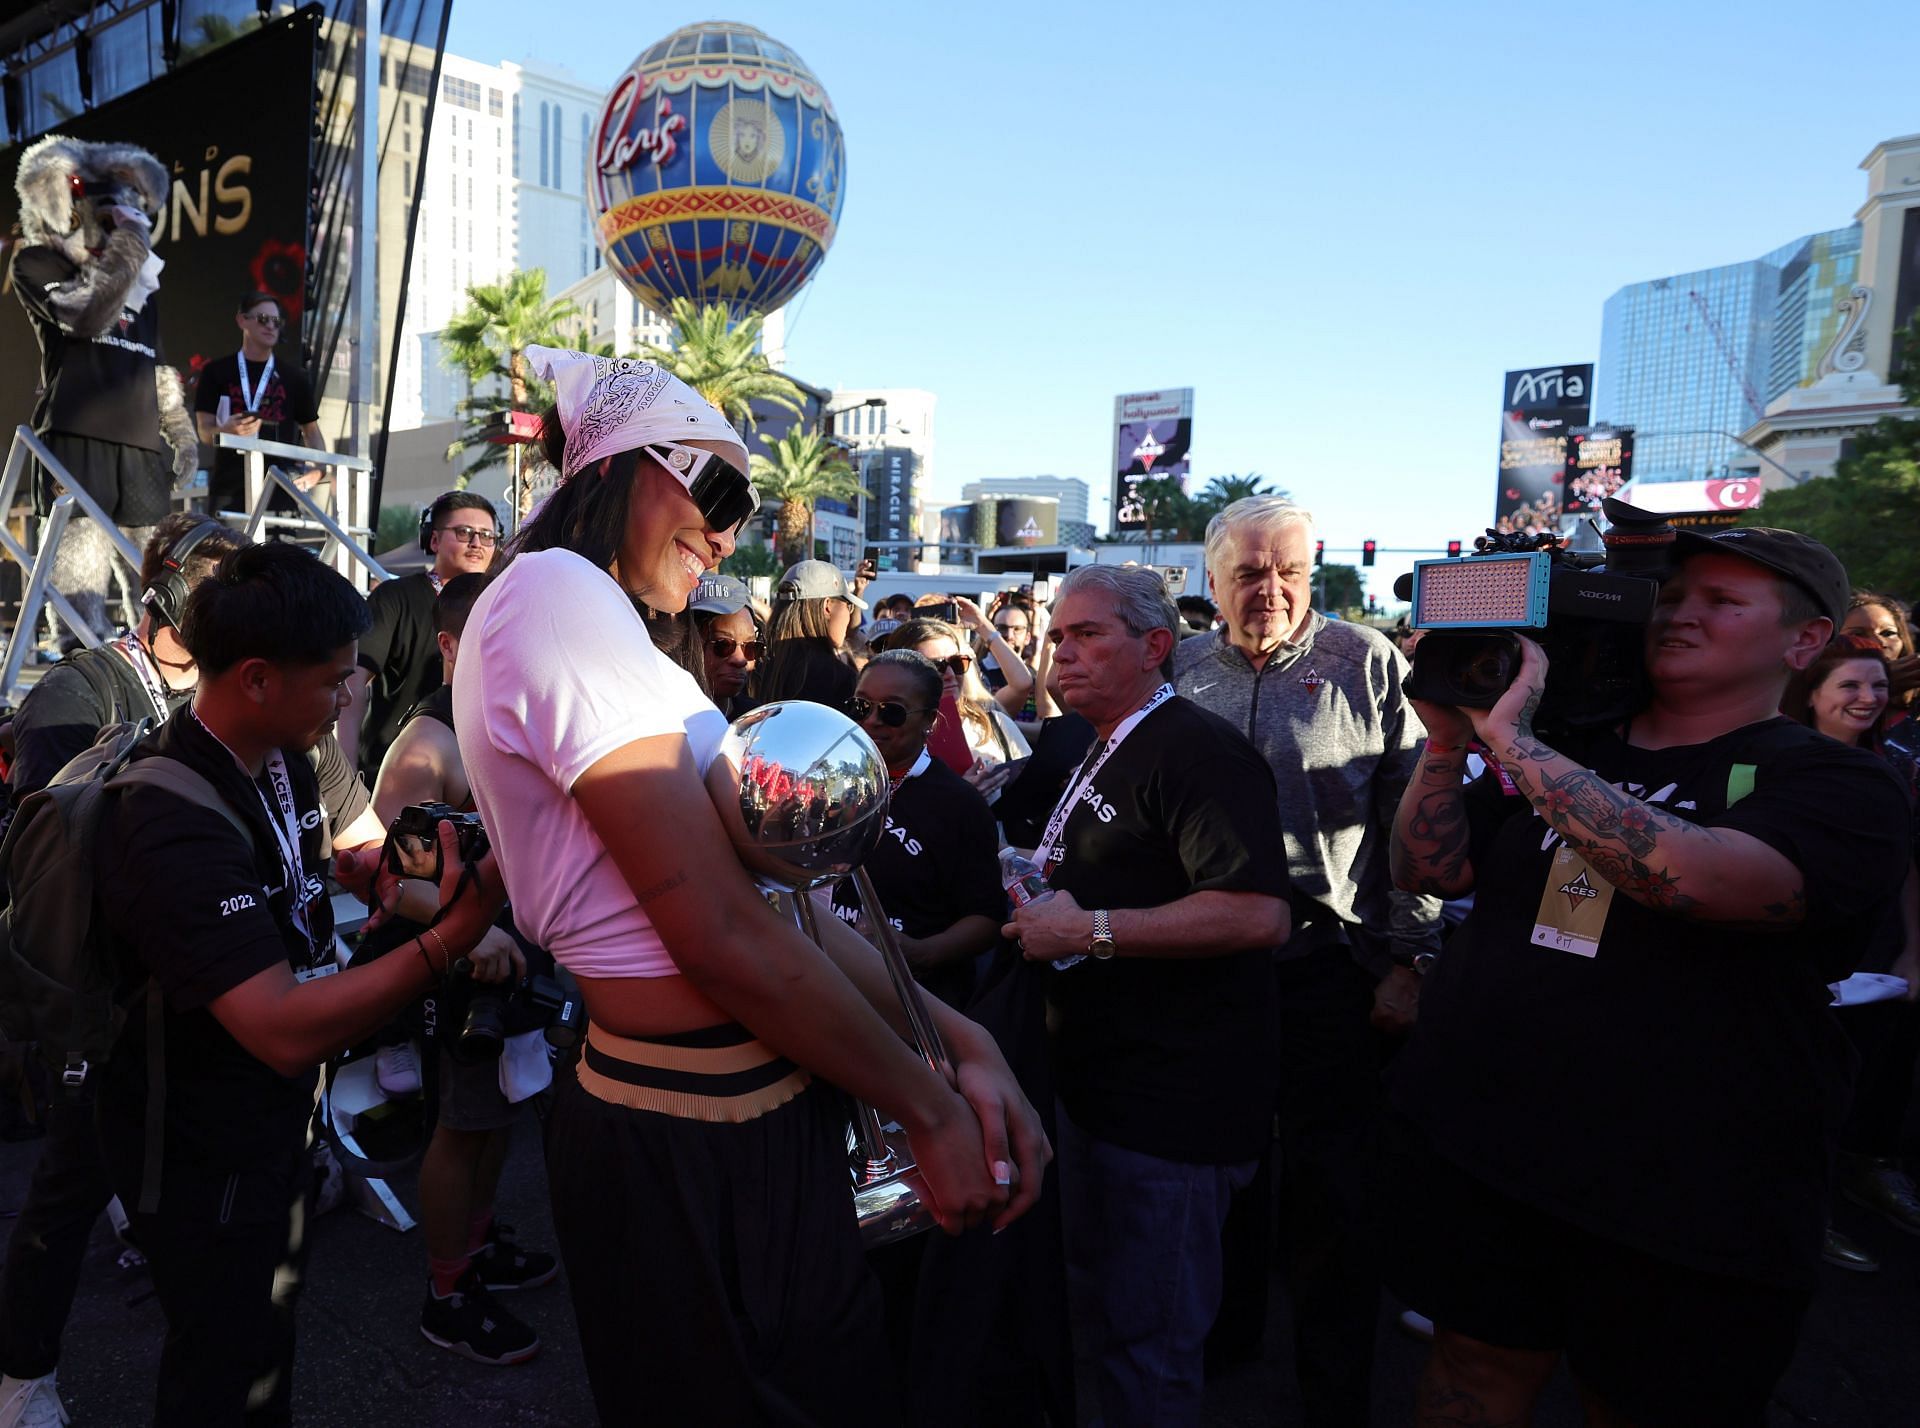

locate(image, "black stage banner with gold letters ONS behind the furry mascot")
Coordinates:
0 10 321 434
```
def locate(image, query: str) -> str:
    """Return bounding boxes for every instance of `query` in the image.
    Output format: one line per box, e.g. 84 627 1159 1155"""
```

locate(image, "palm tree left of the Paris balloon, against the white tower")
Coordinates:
442 269 580 486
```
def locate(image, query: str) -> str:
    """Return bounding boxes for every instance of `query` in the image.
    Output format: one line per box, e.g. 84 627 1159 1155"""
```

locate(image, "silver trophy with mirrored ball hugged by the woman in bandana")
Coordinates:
714 699 954 1250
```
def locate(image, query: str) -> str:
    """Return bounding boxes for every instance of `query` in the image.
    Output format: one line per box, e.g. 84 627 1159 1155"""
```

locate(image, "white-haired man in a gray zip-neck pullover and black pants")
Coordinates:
1173 495 1440 1428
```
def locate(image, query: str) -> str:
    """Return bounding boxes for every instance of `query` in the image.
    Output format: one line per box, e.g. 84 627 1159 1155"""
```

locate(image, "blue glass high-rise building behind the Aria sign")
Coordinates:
1594 228 1860 482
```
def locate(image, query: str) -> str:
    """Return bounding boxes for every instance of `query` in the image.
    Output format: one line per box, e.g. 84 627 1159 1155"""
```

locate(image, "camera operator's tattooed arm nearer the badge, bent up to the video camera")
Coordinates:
1469 639 1807 927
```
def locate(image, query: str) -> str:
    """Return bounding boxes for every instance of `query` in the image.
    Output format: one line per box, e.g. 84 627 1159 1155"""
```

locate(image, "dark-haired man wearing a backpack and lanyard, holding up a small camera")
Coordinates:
94 543 499 1426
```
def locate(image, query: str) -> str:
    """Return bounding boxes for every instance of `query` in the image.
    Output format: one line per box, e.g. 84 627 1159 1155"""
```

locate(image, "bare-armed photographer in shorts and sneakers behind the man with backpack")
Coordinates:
372 576 559 1365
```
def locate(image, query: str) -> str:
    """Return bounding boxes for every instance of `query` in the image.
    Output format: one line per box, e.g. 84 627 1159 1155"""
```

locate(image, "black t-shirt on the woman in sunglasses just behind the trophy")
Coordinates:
833 758 1006 1006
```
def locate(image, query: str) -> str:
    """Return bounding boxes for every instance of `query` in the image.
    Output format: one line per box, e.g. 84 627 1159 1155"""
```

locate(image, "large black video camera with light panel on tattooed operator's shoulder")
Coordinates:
1394 497 1674 733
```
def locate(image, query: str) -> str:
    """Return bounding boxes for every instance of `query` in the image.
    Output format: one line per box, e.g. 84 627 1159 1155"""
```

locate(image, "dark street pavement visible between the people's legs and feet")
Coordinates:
11 1119 1920 1428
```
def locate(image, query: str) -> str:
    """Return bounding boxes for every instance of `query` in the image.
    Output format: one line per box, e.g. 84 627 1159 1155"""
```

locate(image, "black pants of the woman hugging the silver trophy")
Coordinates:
547 1067 900 1428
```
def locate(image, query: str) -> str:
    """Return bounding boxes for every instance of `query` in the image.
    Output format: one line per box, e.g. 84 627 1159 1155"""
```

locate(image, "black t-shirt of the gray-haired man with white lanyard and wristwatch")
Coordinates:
1046 697 1286 1165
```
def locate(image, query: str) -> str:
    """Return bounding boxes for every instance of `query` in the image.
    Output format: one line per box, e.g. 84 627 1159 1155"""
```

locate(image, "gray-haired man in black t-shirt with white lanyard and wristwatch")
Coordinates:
1006 566 1290 1428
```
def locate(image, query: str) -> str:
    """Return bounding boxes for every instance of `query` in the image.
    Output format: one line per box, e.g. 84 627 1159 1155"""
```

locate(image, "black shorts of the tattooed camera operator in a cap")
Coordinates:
1380 1117 1812 1428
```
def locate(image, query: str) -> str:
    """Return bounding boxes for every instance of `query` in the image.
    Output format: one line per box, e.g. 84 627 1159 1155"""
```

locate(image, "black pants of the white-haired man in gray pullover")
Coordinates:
1275 946 1382 1428
